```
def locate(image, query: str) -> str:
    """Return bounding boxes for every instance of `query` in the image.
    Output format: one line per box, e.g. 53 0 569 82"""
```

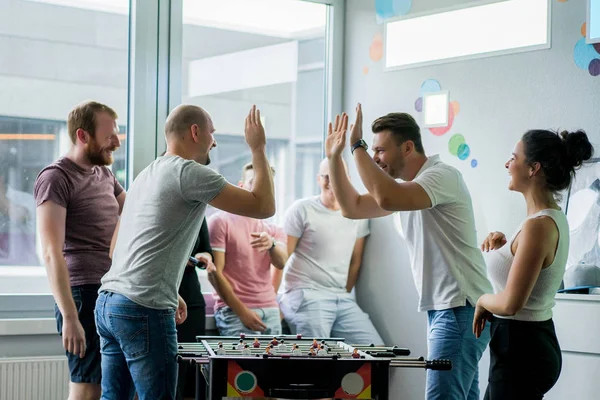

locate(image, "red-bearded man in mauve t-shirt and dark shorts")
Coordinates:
34 102 125 400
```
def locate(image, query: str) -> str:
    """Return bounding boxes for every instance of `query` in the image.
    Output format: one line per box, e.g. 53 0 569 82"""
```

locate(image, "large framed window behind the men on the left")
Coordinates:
0 0 344 293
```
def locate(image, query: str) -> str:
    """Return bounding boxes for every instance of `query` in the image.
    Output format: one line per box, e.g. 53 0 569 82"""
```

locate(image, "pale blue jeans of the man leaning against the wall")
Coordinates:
279 289 383 345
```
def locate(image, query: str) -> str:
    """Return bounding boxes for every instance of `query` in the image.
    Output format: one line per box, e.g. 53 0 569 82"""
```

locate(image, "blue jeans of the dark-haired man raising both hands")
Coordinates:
426 305 490 400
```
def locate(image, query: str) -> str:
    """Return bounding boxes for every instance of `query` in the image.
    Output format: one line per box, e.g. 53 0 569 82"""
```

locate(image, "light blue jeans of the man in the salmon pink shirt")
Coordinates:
215 307 281 336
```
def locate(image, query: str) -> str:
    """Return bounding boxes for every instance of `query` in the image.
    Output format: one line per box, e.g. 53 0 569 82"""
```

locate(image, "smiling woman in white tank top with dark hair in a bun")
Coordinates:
473 130 593 400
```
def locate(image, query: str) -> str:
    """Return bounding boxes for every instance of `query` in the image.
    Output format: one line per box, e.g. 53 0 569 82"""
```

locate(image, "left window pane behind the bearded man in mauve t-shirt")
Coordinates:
0 0 129 266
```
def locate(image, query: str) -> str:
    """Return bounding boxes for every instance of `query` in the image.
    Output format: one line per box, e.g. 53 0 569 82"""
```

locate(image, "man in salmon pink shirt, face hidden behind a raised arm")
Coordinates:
208 164 288 336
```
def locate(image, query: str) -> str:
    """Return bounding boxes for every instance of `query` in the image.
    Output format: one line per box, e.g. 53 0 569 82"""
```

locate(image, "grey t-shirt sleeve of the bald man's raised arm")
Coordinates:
181 161 227 203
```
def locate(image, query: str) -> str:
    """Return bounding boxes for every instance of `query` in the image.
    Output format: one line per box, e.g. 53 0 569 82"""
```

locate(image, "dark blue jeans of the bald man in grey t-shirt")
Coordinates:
95 291 177 400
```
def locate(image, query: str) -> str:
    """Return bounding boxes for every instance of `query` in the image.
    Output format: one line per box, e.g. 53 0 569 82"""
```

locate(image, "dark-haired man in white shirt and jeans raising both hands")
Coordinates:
325 104 492 400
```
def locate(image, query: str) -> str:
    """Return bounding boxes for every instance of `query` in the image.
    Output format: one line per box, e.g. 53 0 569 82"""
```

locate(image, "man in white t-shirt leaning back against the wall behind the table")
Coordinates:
279 160 383 344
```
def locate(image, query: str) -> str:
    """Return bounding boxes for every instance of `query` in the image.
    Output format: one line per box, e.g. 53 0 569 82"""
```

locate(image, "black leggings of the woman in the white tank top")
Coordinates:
485 317 562 400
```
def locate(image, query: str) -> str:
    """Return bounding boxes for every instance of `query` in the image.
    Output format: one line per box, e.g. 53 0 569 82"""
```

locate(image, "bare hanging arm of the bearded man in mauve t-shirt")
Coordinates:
37 201 86 358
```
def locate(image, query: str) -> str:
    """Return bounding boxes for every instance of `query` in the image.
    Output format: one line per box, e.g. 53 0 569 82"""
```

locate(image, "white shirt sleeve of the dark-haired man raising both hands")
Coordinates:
413 167 459 207
